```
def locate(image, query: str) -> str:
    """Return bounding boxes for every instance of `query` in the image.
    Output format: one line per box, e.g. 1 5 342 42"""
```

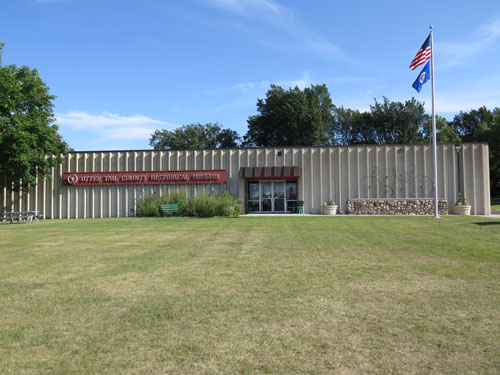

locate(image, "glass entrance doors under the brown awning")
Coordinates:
247 181 297 212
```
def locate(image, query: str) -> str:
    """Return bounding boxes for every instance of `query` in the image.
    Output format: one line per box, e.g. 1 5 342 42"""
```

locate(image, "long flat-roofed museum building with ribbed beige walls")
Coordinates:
0 143 490 219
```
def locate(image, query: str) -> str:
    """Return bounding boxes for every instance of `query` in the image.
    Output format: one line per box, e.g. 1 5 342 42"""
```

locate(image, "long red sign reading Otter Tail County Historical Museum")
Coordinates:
63 169 226 186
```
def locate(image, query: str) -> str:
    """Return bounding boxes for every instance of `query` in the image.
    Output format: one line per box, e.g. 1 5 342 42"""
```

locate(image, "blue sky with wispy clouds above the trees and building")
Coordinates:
0 0 500 150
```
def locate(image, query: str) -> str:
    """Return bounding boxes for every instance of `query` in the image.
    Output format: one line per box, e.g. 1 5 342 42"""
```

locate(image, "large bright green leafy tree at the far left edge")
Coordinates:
0 45 68 192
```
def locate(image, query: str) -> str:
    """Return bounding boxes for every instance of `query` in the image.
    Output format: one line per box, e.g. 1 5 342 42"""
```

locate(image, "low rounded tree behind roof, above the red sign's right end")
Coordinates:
149 123 240 150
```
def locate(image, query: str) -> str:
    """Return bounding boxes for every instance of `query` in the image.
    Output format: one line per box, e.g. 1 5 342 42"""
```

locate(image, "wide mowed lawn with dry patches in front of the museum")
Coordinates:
0 216 500 374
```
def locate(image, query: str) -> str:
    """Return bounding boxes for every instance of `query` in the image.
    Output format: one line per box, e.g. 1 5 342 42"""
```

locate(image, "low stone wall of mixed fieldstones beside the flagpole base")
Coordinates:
346 198 448 215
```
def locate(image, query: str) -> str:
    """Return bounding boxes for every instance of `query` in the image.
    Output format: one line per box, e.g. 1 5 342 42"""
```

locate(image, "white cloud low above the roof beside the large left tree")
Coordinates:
56 111 178 140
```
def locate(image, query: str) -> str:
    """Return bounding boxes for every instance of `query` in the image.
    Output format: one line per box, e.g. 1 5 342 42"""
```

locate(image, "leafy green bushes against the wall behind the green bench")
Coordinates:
137 191 241 217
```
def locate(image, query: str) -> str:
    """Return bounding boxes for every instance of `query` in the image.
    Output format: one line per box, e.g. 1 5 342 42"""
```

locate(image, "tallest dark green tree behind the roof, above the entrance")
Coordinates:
244 85 333 146
